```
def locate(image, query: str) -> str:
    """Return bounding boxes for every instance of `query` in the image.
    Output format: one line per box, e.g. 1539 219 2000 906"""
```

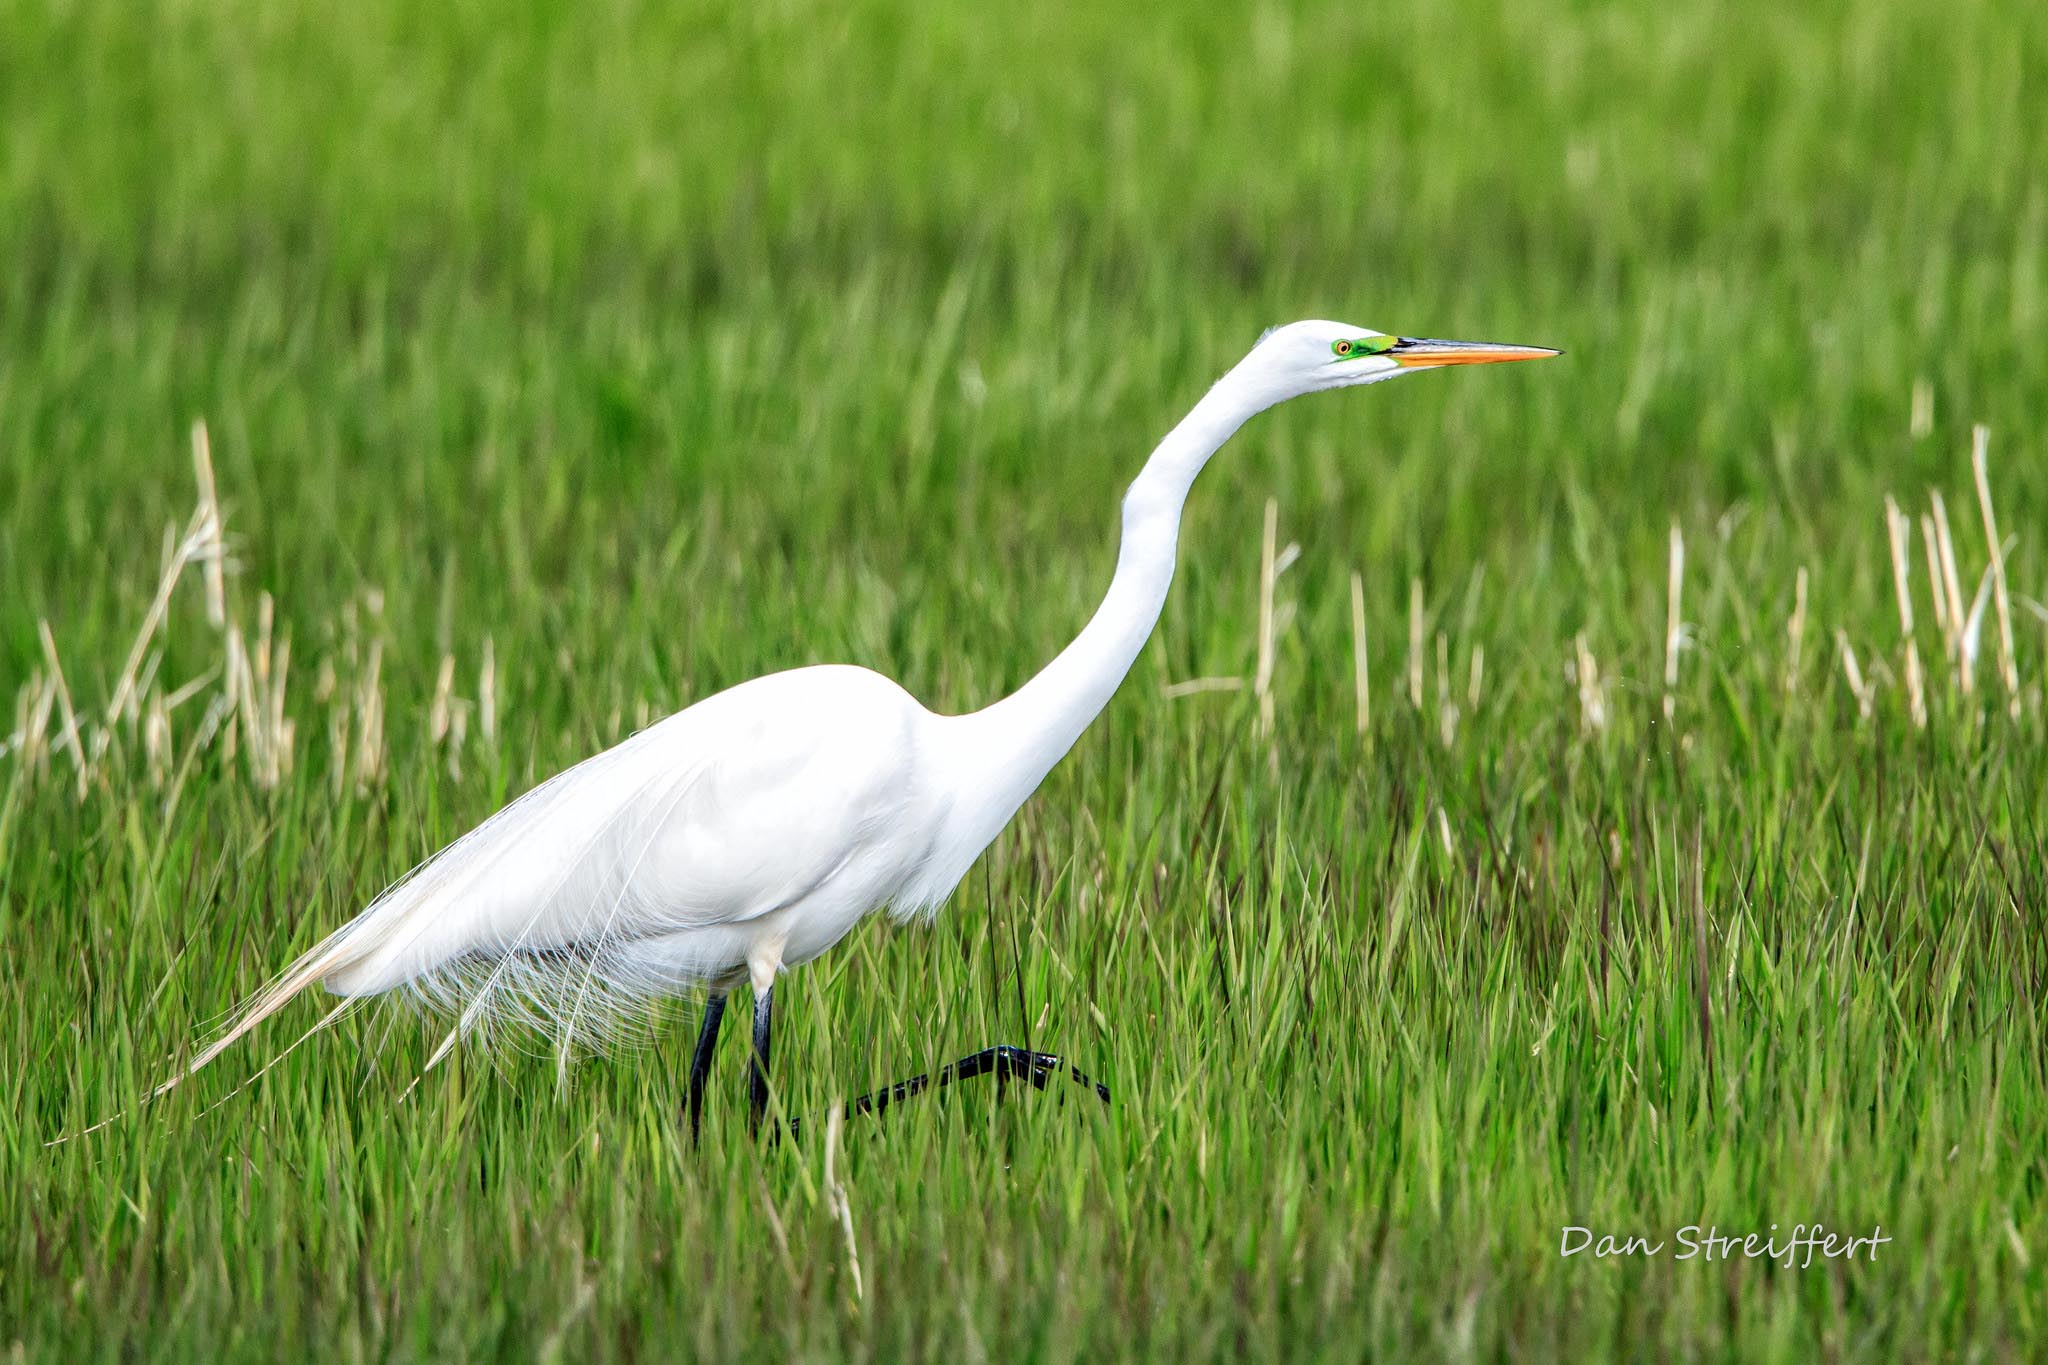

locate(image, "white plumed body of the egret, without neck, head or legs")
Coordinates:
292 665 1024 1046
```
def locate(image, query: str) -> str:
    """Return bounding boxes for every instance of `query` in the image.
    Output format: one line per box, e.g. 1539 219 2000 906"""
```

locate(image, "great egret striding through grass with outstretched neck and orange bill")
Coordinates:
144 321 1559 1136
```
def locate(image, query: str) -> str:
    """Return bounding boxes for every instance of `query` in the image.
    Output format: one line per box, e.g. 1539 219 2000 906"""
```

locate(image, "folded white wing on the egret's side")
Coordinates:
326 669 915 995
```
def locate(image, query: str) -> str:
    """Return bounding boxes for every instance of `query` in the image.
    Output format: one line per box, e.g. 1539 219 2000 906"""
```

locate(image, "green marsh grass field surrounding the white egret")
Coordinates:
0 0 2048 1361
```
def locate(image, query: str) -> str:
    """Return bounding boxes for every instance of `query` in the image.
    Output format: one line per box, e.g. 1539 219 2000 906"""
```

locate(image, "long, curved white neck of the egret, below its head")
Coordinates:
937 364 1282 839
